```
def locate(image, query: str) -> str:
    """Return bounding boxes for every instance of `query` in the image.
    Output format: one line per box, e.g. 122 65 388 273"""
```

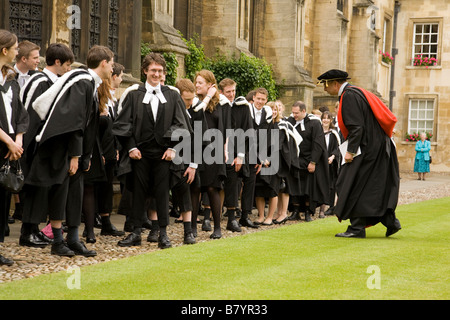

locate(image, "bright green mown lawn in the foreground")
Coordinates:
0 198 450 300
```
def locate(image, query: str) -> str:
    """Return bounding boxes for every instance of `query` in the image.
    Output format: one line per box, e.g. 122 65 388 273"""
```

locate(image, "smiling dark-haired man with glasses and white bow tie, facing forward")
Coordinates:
113 53 192 249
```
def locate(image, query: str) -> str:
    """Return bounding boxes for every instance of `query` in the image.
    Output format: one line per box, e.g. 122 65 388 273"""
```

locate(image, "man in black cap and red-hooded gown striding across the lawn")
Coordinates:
318 69 401 238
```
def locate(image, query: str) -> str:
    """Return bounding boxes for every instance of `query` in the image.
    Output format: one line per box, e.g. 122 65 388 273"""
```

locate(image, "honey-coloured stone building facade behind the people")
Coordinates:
0 0 450 171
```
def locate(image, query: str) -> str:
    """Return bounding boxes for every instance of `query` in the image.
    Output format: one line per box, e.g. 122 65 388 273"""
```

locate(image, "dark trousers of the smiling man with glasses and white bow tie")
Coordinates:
130 158 170 228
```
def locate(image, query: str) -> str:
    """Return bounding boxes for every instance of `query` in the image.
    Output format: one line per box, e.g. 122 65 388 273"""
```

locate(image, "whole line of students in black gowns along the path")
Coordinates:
0 30 339 265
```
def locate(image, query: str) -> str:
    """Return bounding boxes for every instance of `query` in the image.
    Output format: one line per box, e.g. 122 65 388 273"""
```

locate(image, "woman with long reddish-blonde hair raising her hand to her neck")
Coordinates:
194 70 231 239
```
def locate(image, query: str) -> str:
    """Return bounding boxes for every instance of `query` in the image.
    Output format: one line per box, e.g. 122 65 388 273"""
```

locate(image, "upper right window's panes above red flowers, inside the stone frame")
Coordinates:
412 23 439 61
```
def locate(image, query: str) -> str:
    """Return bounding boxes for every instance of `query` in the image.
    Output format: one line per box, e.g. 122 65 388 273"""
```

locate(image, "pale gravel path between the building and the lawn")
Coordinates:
0 173 450 283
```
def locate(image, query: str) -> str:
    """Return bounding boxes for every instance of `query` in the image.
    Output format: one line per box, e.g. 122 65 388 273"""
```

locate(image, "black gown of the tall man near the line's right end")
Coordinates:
288 114 330 212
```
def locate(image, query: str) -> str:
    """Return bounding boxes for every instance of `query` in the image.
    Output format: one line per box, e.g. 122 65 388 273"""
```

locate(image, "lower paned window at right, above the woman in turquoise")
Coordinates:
408 99 435 133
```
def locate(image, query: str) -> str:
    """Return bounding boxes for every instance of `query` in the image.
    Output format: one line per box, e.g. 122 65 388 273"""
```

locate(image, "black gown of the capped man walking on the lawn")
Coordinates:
334 85 400 220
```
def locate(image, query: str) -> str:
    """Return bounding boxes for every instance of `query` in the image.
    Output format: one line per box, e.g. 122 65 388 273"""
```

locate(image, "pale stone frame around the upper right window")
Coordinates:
406 17 444 69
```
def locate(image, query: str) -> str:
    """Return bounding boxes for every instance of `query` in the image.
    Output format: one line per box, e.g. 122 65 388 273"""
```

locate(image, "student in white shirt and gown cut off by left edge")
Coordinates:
0 30 28 266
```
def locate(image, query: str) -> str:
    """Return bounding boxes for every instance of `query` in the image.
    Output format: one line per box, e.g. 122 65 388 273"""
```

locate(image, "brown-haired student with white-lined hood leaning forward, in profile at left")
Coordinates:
27 46 114 256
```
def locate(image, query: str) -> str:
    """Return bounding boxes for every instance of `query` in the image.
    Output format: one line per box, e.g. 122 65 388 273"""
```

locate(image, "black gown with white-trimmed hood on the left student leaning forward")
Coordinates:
26 70 98 187
